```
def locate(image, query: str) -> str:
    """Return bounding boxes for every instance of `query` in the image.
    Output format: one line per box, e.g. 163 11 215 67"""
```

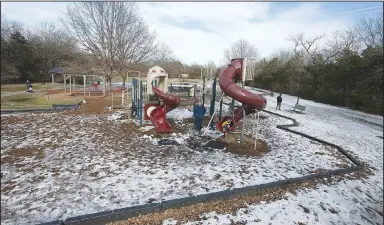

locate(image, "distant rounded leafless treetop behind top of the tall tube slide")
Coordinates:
224 39 259 63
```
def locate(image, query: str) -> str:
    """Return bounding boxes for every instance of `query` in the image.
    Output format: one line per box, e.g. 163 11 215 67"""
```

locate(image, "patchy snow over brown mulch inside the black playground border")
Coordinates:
1 106 349 225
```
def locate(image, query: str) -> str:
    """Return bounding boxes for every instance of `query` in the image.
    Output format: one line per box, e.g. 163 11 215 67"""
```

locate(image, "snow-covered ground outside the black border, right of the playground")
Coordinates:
164 89 383 225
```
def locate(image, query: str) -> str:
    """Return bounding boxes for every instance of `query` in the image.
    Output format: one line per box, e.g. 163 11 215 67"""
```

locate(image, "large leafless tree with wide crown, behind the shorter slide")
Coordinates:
62 2 156 87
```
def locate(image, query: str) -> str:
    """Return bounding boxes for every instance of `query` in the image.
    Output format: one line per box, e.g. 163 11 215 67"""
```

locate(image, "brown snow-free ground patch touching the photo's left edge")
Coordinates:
1 146 44 165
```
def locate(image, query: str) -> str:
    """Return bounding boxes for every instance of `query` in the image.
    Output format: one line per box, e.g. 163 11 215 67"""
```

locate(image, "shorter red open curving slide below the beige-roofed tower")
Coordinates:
149 85 181 133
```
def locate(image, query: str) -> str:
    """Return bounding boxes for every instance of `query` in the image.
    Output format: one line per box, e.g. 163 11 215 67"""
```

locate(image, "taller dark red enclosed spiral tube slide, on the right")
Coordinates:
217 59 267 133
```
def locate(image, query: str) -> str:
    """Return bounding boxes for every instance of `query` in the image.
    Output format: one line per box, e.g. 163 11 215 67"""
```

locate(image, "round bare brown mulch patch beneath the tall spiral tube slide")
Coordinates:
218 133 268 156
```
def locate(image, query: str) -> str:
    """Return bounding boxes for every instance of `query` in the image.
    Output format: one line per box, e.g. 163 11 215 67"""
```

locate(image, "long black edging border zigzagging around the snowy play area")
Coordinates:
35 110 364 225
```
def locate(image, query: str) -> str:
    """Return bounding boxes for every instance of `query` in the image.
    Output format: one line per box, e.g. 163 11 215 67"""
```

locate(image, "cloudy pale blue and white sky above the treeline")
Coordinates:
1 2 383 64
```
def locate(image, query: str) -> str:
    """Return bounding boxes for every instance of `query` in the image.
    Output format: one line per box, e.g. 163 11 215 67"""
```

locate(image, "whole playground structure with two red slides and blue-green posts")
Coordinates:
132 58 267 142
